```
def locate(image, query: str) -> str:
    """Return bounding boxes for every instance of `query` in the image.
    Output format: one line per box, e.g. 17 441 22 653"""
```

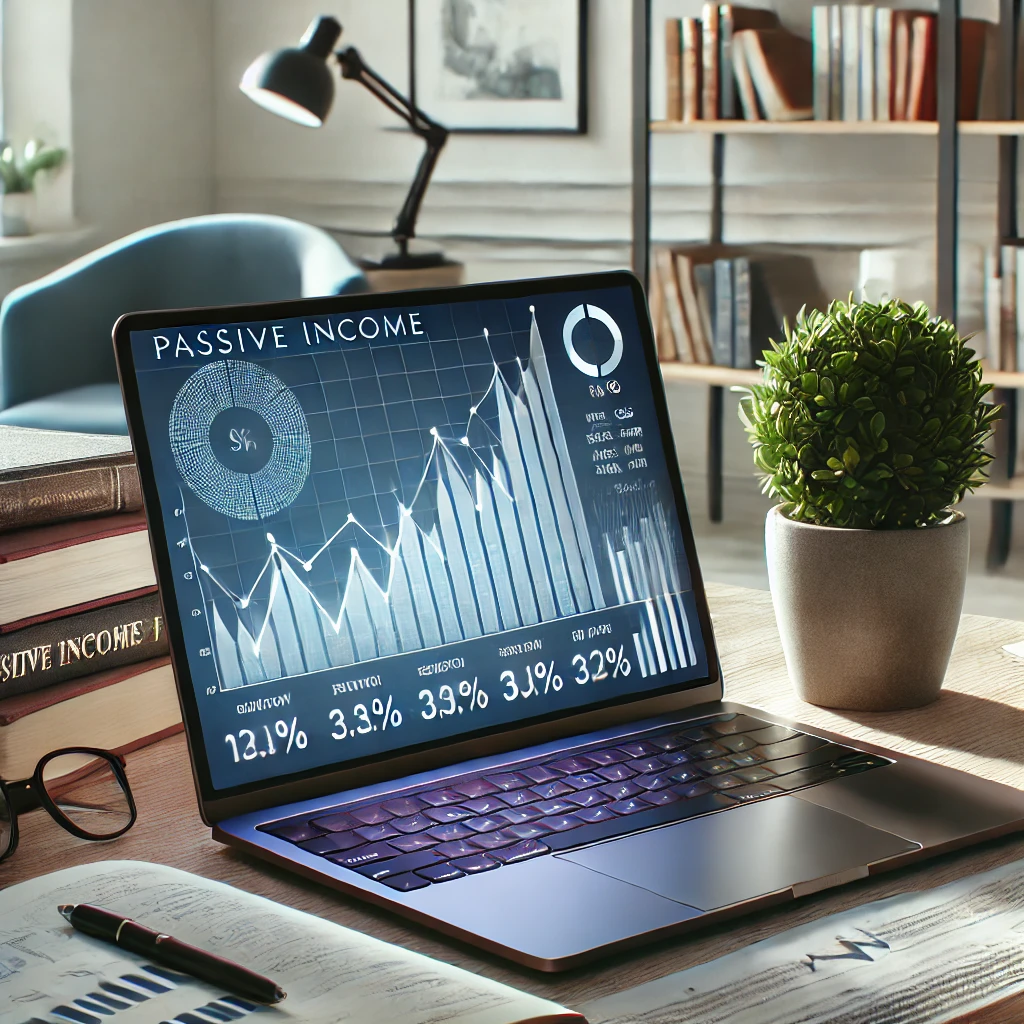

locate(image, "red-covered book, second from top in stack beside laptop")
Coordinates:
0 512 157 627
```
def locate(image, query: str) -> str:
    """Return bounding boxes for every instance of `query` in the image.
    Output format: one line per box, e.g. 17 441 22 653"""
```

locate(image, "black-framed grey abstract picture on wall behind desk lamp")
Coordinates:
410 0 587 133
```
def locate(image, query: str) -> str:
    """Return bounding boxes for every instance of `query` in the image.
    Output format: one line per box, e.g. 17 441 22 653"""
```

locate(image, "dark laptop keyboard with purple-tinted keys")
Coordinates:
259 715 891 892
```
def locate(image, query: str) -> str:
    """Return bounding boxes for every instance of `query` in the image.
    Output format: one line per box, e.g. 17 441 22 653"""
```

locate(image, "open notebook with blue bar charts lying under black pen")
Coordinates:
0 860 586 1024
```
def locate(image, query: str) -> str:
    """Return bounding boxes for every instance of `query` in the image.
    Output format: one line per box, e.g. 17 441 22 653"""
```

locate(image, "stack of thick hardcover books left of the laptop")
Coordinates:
0 426 181 779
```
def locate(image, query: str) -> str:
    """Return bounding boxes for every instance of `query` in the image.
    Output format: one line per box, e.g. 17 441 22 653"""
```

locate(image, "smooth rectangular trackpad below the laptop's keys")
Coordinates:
558 797 921 910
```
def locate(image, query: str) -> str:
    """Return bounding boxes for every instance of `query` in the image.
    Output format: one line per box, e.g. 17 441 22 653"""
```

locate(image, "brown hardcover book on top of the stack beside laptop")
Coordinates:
0 425 142 531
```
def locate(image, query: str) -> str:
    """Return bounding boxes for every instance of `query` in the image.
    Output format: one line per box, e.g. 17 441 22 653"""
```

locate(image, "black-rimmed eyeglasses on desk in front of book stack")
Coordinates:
0 746 136 861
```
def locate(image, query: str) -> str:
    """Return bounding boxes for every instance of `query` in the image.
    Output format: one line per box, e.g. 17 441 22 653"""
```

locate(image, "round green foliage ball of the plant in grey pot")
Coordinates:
739 299 999 529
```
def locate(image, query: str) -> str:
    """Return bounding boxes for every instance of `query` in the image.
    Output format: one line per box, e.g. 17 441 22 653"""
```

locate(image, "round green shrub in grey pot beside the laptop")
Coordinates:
739 299 998 711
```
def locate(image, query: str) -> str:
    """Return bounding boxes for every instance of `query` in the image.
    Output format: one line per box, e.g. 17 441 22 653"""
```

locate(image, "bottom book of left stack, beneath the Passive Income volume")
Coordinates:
0 657 181 779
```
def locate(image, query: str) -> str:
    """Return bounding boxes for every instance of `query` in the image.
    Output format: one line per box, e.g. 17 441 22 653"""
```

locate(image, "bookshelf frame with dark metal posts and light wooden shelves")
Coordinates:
631 0 1024 568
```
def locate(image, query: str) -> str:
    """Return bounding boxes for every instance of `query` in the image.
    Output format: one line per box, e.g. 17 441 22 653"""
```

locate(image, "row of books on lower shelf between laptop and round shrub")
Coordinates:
648 246 825 370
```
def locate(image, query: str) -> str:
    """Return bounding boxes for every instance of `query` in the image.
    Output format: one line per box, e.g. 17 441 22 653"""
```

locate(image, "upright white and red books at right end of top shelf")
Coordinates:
811 4 998 121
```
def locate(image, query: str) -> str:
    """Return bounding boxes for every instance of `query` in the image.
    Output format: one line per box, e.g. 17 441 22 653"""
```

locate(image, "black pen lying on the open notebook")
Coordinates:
57 903 285 1004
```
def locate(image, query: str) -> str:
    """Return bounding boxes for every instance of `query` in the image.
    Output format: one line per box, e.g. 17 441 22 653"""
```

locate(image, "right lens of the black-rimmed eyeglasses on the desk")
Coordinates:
43 752 131 839
